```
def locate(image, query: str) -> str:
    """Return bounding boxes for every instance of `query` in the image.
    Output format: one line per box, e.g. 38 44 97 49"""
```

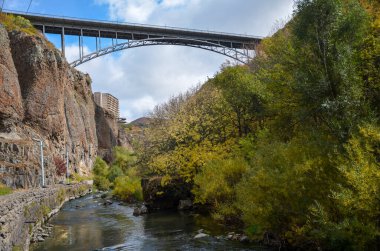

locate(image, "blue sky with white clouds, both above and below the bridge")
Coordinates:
0 0 293 121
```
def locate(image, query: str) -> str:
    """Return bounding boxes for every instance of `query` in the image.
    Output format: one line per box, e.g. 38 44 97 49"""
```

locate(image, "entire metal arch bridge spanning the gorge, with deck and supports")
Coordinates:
3 10 262 67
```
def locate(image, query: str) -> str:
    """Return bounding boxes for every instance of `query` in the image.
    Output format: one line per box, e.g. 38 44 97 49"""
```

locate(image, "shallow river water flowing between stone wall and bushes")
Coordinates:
31 195 265 251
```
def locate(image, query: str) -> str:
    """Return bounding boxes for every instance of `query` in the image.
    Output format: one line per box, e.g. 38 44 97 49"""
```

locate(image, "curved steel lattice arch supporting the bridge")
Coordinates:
70 37 252 67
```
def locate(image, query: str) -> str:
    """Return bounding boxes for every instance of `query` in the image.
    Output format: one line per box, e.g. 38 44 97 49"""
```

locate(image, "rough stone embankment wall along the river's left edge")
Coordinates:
0 183 92 251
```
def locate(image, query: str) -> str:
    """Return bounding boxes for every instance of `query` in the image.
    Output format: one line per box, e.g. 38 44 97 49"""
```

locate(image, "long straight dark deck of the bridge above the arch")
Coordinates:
4 11 262 49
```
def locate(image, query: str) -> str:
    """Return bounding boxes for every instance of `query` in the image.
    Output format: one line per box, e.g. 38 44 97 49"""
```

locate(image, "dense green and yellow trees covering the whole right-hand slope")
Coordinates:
132 0 380 250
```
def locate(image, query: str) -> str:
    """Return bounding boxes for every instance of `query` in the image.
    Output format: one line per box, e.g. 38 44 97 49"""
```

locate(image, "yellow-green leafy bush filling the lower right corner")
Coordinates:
302 124 380 250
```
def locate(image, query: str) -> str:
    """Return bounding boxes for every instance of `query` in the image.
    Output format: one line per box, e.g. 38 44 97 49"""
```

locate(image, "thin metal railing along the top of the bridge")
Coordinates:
3 9 264 39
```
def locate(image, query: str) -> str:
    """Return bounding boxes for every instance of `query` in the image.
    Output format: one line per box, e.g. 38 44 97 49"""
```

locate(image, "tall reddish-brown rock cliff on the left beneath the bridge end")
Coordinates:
0 24 98 188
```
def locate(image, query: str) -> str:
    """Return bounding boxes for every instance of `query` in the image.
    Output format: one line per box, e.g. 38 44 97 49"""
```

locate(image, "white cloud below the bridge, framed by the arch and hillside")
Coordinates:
66 44 224 121
